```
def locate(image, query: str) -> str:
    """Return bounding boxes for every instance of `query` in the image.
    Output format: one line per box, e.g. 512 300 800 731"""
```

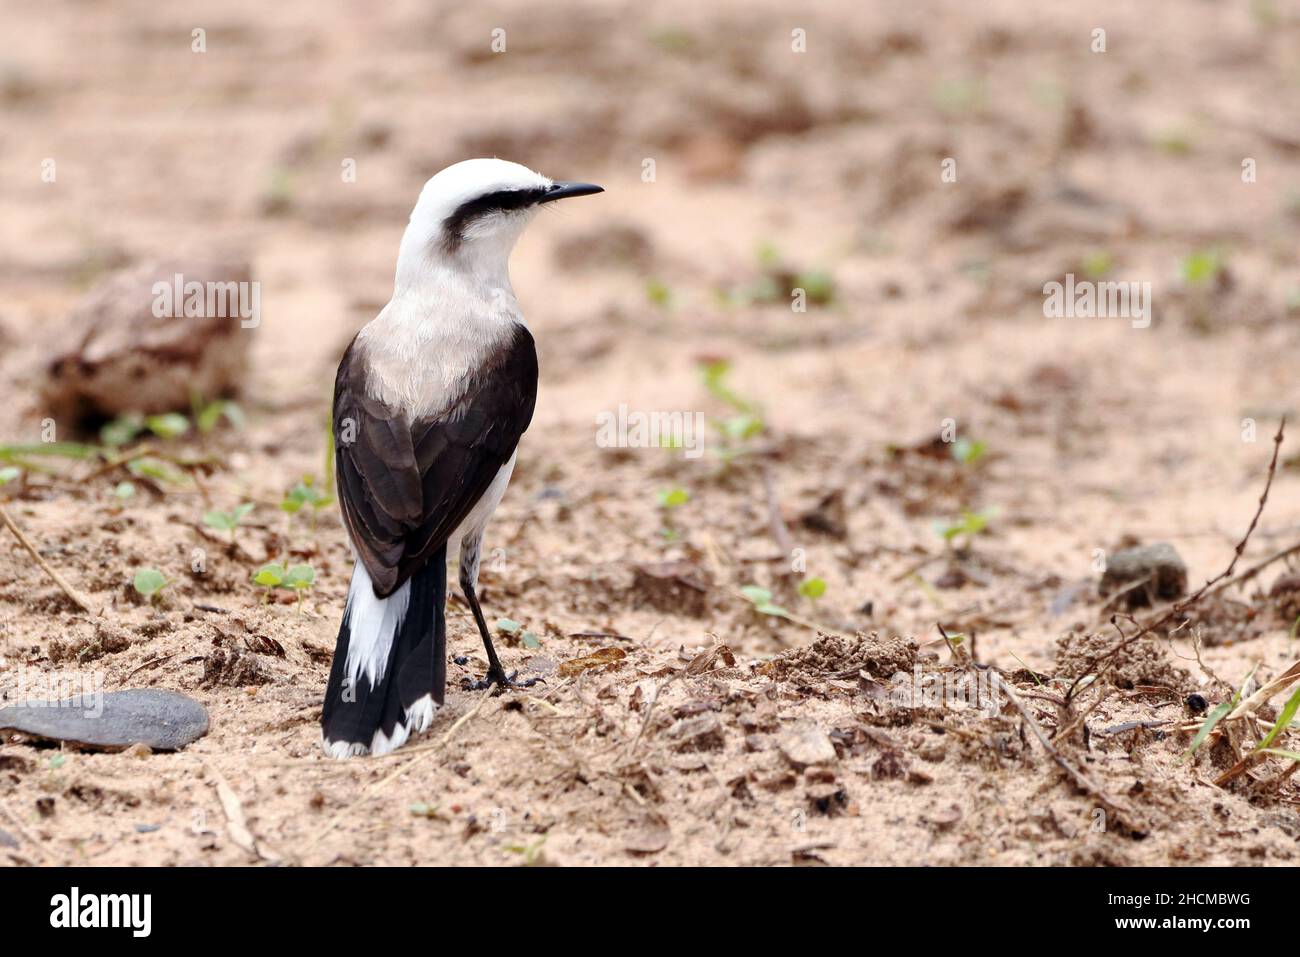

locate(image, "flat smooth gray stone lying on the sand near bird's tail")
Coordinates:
0 688 208 752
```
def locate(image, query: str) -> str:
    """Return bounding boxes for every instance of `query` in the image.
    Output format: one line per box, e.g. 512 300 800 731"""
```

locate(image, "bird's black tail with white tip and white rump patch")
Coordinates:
321 545 447 758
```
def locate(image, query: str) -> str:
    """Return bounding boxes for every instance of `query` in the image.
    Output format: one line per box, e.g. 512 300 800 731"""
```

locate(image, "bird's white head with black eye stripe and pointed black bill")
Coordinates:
398 159 603 286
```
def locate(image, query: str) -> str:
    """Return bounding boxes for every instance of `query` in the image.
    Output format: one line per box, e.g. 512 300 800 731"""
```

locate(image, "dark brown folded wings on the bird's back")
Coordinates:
334 326 537 598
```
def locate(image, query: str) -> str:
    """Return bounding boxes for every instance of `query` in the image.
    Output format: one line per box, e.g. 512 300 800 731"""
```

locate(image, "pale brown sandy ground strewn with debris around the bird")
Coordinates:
0 0 1300 865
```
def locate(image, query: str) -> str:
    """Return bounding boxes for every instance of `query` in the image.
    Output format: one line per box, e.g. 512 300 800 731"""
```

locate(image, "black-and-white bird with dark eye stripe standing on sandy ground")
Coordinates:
321 159 603 758
